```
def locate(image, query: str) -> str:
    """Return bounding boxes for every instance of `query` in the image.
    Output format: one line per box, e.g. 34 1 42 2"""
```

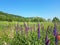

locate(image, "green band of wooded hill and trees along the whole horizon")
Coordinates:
0 11 60 22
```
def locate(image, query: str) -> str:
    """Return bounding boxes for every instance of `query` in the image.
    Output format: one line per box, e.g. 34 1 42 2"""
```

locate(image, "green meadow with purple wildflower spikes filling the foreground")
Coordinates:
0 22 60 45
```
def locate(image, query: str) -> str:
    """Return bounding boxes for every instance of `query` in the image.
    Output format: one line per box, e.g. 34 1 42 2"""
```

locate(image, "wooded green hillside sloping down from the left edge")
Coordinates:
0 11 24 21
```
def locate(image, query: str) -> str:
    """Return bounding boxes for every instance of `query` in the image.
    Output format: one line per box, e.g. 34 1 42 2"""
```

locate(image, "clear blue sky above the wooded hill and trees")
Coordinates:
0 0 60 19
